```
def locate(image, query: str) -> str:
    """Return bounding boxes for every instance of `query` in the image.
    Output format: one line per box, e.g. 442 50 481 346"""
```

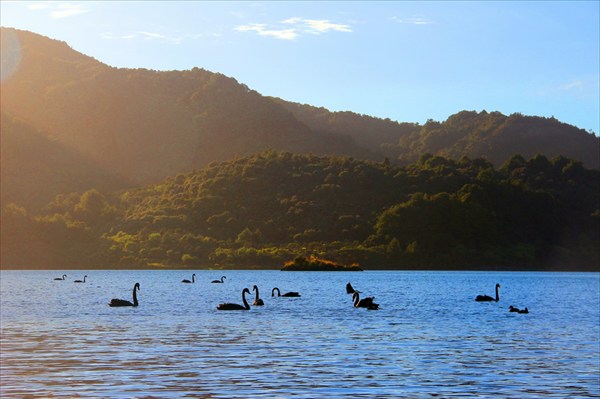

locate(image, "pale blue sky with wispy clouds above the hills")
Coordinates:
0 0 600 135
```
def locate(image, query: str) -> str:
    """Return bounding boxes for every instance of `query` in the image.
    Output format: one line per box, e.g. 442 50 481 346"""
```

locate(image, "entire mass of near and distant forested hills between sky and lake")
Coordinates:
0 28 600 270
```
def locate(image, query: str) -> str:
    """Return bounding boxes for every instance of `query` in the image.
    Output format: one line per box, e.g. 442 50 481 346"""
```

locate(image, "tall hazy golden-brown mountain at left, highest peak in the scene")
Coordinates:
2 28 369 187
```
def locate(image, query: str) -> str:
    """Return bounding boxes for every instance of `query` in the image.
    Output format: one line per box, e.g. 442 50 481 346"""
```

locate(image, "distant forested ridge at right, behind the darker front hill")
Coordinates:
274 99 600 169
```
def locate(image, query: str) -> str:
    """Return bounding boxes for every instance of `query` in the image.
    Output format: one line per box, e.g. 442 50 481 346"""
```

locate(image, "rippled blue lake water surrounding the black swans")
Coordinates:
0 270 600 398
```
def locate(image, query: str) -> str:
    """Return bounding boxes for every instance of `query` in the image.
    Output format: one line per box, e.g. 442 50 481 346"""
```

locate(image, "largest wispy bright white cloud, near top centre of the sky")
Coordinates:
234 17 352 40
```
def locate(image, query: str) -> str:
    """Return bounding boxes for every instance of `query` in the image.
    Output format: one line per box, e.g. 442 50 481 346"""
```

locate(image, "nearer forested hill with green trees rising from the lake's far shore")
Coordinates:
0 151 600 271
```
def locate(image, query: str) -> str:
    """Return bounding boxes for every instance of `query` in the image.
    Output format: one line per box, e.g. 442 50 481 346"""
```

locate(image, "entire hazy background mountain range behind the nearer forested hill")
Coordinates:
0 28 600 214
